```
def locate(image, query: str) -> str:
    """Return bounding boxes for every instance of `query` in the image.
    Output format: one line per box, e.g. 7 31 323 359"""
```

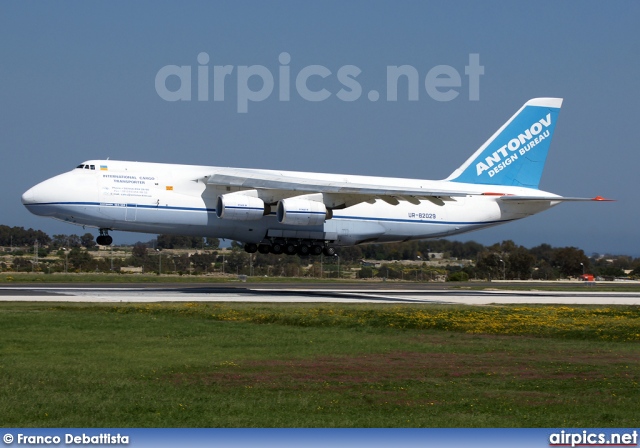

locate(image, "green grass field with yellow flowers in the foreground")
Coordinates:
0 303 640 427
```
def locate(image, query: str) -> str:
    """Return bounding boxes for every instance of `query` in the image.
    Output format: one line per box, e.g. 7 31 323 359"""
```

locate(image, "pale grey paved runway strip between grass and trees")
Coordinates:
0 285 640 305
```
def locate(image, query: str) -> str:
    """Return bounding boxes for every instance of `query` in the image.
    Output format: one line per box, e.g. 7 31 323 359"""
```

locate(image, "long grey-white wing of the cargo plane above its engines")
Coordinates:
206 169 478 206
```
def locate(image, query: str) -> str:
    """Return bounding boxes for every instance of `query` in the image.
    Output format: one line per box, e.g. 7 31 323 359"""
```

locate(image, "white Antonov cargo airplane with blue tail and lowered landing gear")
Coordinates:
22 98 607 256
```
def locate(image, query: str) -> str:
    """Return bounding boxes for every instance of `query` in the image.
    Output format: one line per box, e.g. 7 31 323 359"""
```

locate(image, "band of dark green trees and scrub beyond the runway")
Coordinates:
0 225 640 281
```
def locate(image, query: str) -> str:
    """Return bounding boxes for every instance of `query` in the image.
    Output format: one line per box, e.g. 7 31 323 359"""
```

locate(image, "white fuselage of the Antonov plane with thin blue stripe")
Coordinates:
22 160 556 246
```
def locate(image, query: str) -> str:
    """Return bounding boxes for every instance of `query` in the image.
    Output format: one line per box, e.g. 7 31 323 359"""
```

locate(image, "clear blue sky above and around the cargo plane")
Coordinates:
0 1 640 256
